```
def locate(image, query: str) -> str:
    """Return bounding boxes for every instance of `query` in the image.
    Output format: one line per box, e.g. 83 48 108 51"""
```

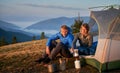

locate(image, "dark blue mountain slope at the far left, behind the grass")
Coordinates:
0 20 33 43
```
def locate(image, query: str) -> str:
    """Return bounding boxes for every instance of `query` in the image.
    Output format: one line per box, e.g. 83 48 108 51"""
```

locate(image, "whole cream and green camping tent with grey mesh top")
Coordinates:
85 8 120 72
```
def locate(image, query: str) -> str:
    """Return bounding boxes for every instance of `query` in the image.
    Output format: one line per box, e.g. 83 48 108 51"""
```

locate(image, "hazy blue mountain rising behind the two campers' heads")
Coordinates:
26 17 89 30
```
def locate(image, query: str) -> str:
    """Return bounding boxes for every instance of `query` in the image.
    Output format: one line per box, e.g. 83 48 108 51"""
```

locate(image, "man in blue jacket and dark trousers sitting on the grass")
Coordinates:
37 25 74 64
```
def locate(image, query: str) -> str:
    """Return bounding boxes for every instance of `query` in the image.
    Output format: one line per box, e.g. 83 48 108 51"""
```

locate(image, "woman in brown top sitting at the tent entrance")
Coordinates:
72 23 93 55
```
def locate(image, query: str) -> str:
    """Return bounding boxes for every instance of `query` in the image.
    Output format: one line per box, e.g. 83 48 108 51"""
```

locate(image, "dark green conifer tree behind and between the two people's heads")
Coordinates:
71 13 83 33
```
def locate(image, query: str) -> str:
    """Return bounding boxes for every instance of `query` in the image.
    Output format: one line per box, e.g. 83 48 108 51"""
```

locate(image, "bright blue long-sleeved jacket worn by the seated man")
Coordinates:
46 32 74 48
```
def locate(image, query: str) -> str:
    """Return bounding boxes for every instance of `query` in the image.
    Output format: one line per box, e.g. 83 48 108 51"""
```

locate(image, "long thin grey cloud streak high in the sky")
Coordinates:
20 4 85 10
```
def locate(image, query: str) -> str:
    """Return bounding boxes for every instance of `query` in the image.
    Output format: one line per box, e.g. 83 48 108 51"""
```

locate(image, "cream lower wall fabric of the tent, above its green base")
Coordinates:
94 39 120 63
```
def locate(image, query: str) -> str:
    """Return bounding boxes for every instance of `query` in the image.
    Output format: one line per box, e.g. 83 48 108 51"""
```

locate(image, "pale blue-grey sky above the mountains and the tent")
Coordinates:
0 0 120 28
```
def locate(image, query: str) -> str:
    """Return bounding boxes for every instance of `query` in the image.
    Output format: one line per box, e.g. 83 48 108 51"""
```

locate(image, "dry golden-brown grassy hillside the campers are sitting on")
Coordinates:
0 39 120 73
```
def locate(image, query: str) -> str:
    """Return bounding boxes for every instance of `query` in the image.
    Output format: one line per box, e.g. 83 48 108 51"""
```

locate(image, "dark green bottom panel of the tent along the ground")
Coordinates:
85 58 120 71
